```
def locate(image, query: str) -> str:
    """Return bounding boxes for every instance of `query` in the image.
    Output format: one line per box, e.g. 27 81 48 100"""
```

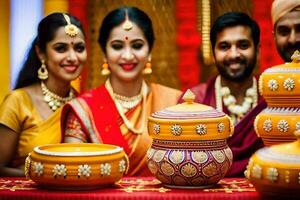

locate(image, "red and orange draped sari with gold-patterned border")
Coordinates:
61 84 181 176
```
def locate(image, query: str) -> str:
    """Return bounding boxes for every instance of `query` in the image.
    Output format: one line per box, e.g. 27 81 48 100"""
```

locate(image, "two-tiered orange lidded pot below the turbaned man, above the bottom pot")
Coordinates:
254 51 300 146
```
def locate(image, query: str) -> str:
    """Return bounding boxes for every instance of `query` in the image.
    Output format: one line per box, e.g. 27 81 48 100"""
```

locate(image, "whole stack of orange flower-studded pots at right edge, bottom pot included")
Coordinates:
245 51 300 199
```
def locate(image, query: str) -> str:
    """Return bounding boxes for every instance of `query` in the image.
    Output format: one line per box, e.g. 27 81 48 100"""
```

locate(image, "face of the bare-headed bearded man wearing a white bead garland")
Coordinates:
214 25 258 82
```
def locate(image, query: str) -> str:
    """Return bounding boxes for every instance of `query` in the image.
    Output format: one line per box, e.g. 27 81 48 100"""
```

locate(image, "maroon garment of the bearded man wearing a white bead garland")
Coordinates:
192 77 267 177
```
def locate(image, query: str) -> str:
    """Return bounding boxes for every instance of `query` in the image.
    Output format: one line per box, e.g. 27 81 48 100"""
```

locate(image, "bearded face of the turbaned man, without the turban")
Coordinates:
274 10 300 62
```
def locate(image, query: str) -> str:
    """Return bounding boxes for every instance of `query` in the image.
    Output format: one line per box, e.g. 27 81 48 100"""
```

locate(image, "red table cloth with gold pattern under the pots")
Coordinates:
0 177 260 200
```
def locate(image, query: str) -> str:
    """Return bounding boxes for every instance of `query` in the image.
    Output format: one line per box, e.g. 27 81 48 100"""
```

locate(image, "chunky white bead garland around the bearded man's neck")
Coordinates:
215 75 258 124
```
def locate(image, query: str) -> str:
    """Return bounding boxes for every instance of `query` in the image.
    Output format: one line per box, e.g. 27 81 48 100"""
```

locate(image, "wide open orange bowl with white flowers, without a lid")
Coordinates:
25 143 129 190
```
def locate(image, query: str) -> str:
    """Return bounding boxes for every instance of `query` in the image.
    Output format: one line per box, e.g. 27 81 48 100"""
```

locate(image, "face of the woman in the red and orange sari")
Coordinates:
105 23 150 82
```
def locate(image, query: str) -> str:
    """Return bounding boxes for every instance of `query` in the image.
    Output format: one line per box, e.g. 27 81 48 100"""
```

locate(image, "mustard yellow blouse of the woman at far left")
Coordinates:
0 89 61 167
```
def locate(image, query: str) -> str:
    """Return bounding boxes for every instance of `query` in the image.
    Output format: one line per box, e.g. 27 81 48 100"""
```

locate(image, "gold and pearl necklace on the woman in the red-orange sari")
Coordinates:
105 79 148 134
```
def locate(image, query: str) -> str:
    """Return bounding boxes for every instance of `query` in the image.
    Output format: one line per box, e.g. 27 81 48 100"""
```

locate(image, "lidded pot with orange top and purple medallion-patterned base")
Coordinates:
147 90 234 188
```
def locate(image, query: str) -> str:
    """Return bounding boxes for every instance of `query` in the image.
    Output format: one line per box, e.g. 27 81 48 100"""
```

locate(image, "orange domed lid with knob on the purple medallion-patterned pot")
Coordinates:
148 90 234 140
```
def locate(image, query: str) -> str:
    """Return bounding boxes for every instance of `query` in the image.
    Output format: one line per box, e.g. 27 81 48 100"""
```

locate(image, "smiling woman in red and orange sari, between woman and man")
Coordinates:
62 7 181 175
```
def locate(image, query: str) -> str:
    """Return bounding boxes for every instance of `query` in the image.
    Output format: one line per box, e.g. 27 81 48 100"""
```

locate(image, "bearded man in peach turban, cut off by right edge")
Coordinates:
271 0 300 62
